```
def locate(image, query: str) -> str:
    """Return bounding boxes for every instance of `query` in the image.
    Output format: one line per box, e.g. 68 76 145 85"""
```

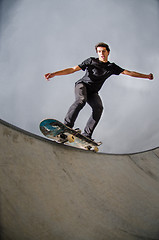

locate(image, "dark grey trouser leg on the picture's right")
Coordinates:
84 93 103 138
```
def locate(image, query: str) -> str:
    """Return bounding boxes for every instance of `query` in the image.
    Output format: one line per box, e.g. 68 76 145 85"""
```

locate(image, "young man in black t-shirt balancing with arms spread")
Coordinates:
45 42 153 138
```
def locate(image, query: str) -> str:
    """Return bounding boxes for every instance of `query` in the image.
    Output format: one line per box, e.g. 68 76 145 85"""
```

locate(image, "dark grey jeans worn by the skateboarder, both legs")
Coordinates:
64 83 103 137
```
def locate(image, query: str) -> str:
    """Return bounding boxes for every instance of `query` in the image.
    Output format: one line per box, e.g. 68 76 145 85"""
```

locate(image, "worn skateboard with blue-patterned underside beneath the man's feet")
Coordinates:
39 119 102 152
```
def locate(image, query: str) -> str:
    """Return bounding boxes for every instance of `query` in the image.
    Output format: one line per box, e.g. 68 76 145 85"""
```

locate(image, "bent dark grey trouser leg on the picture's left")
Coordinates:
64 83 87 128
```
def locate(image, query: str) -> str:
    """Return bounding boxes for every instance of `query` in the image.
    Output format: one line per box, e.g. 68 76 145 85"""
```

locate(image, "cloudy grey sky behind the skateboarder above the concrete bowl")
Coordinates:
0 0 159 153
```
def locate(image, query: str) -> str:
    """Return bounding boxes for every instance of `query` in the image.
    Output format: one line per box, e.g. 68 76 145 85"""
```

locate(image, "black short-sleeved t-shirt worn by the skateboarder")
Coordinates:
76 57 124 92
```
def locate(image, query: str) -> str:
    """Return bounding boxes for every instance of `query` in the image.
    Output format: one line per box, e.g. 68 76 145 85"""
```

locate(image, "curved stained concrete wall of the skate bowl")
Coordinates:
0 121 159 240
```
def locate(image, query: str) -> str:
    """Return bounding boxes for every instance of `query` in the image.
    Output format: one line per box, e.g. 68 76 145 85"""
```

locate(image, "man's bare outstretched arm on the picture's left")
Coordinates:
44 65 81 80
